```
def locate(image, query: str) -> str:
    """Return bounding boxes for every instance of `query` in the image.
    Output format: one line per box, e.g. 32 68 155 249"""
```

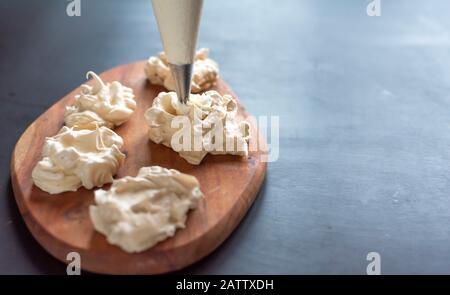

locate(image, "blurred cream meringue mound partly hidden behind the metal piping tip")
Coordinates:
145 48 219 93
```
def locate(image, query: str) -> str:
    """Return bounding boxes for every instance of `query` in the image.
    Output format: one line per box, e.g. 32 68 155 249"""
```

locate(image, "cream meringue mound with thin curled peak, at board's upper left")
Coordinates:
64 72 136 129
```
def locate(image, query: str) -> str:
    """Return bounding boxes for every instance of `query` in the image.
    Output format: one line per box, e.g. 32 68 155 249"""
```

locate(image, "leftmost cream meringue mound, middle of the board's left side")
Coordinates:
32 126 125 194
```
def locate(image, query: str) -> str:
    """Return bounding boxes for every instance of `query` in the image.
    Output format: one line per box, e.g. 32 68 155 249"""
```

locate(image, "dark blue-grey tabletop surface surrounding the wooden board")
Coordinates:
0 0 450 274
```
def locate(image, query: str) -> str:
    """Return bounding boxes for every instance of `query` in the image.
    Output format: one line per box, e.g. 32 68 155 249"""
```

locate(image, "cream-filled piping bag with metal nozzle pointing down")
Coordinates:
152 0 203 104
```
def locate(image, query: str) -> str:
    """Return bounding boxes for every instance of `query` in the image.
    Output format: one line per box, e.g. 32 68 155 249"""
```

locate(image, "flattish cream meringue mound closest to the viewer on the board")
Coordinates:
89 166 203 252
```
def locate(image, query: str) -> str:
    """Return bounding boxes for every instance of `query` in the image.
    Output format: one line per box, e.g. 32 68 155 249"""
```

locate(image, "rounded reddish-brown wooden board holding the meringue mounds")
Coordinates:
11 61 266 274
